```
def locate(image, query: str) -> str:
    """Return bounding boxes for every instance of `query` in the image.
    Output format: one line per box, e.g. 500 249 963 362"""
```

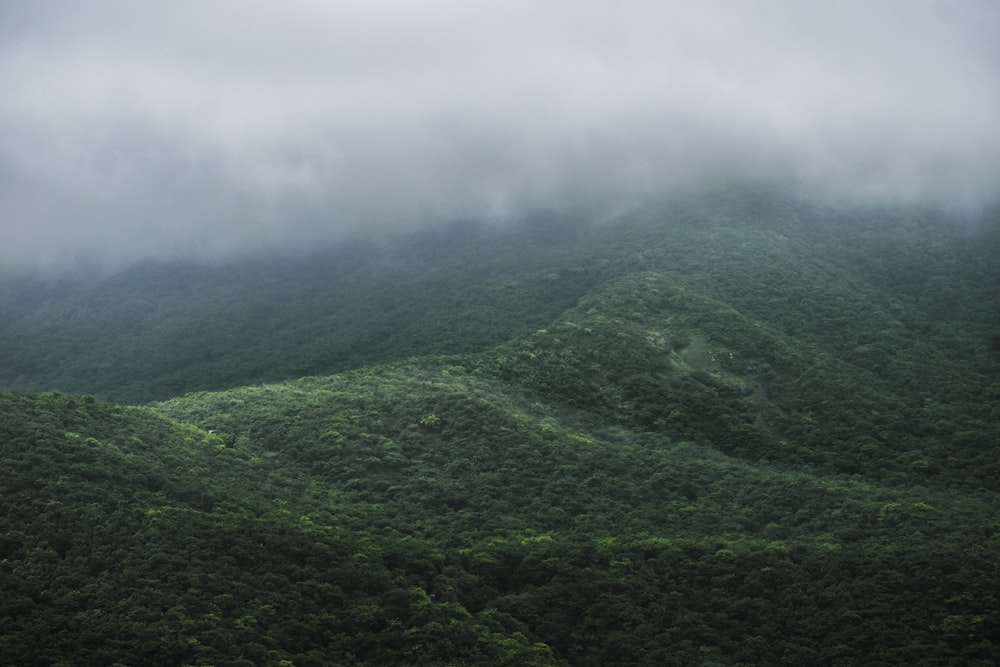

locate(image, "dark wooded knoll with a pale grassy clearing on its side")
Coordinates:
472 272 1000 491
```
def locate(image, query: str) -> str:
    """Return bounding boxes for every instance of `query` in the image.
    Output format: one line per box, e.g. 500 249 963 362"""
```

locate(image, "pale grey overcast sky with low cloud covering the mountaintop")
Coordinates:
0 0 1000 268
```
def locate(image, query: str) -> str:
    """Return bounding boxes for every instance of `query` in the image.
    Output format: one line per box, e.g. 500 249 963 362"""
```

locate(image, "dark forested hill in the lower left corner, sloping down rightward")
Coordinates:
0 395 551 665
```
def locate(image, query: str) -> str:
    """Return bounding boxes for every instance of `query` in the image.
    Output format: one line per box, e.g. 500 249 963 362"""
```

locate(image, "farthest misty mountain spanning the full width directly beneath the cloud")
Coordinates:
0 190 1000 404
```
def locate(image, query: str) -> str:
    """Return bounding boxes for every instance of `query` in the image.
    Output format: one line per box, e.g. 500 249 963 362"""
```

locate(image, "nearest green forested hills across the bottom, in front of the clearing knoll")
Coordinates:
0 359 1000 665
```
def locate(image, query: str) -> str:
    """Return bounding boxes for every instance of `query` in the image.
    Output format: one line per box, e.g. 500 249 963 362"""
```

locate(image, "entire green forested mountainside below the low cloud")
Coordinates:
0 194 1000 665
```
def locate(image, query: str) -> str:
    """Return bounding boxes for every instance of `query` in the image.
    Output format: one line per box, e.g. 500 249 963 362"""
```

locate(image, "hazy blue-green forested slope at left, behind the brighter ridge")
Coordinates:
0 215 599 404
